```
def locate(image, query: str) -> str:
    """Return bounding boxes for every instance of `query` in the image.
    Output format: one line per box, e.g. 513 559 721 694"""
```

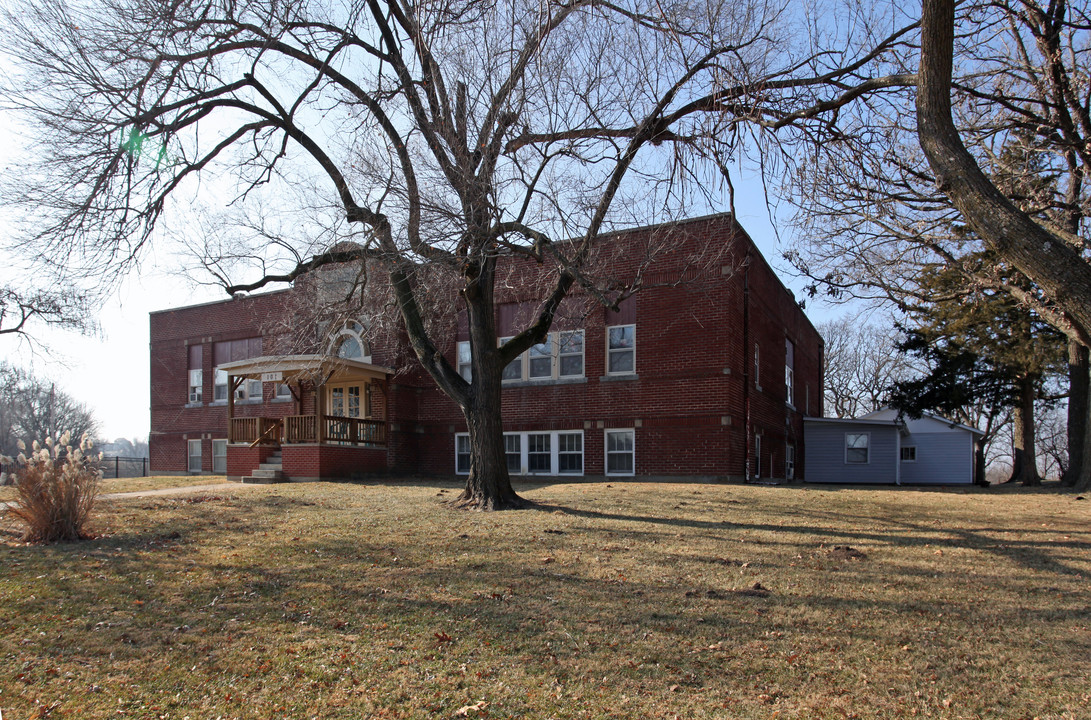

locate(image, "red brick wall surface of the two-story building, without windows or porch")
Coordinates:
152 216 823 484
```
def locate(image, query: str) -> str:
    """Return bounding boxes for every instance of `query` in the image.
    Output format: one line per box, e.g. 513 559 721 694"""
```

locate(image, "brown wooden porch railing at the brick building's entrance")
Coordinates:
229 415 386 445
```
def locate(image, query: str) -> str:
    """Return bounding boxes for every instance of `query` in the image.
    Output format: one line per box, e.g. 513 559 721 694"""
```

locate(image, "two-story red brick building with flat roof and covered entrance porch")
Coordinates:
151 215 823 480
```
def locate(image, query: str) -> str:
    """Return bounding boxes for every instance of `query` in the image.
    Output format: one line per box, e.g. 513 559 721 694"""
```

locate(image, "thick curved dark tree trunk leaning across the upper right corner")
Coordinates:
916 0 1091 338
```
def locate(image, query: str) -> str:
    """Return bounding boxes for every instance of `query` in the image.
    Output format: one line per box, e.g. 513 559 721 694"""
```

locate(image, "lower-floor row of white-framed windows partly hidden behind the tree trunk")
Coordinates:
455 430 584 476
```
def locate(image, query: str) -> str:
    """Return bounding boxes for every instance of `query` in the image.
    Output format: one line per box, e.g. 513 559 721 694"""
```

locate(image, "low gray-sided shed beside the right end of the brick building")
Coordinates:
803 408 983 485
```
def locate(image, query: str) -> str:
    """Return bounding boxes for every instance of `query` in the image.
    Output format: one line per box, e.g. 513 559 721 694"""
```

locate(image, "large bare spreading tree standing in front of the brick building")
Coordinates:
3 0 907 509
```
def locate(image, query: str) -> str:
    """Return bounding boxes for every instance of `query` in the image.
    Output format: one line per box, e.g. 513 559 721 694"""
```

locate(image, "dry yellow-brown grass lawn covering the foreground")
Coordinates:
0 482 1091 720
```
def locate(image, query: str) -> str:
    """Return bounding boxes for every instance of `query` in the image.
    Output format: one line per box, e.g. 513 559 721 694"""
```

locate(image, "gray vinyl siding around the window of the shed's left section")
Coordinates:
804 422 898 484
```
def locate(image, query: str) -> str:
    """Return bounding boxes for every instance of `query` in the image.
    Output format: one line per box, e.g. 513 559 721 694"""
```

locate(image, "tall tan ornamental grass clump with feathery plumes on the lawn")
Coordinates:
2 433 101 543
